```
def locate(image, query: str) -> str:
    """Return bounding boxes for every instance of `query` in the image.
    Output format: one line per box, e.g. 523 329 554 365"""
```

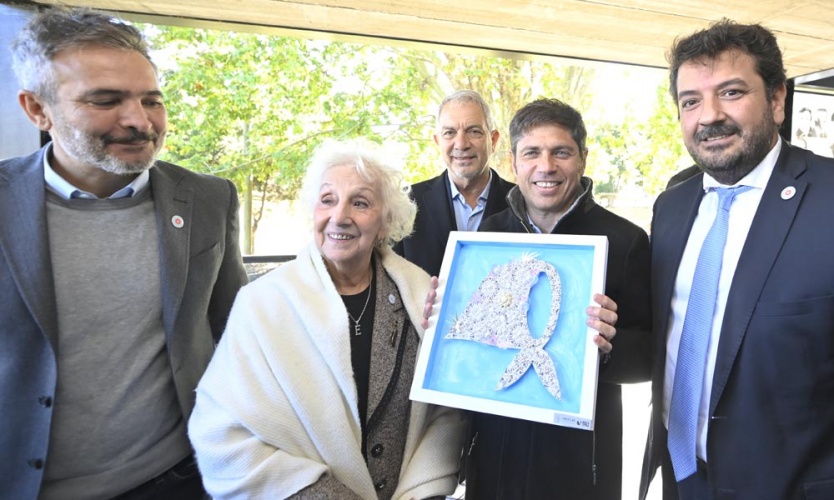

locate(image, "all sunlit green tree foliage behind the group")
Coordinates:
143 25 681 253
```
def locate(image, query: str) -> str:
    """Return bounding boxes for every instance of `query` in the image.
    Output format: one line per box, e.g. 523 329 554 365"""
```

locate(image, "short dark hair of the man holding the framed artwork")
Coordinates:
510 99 588 158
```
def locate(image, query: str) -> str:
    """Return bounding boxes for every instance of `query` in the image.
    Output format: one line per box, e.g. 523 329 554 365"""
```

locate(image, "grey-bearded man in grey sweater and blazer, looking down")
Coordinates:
0 9 246 499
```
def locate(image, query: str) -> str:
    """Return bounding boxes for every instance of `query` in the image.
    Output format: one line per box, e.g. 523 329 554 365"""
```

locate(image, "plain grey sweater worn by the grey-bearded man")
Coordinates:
41 189 190 499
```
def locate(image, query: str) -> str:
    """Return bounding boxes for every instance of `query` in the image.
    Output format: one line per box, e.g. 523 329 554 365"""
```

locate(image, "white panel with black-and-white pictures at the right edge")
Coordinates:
791 91 834 158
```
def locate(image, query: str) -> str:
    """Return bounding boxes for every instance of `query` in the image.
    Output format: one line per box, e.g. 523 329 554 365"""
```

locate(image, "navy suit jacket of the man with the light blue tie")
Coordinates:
641 142 834 500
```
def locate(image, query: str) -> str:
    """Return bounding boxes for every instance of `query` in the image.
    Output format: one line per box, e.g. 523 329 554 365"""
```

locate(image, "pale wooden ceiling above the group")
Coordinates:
27 0 834 76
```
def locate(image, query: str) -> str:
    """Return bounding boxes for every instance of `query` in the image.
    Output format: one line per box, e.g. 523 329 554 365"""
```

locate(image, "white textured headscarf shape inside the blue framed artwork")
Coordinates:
445 253 562 399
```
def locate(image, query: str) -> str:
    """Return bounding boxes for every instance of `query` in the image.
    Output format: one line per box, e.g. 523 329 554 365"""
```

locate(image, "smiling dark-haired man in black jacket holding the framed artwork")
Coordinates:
465 99 651 500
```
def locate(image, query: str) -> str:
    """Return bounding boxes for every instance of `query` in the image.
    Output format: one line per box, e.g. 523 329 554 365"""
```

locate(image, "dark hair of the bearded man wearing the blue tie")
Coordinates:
666 18 787 101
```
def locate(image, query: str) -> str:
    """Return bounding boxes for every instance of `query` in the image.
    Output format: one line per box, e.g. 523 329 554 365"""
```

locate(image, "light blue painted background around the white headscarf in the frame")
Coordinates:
423 241 601 413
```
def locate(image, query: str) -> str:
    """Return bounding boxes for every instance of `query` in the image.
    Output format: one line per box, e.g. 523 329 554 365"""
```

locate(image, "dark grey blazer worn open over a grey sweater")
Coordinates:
0 148 246 499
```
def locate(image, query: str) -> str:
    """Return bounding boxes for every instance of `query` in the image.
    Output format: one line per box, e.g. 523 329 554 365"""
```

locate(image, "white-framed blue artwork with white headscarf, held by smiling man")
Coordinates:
411 231 608 430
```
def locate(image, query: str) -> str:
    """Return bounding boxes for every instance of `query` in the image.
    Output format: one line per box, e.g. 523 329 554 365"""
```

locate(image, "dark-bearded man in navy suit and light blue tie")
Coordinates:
641 20 834 500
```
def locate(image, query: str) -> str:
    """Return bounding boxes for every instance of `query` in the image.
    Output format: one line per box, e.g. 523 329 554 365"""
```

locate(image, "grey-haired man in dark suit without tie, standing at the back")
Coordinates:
394 90 514 276
